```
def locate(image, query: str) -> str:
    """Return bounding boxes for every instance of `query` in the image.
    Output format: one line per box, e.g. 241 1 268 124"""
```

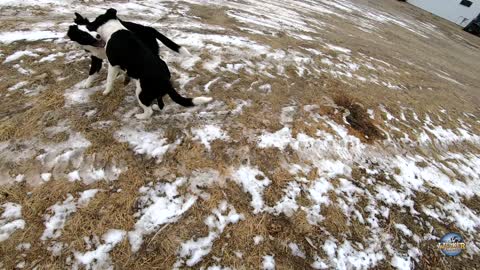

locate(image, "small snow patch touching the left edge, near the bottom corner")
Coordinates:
0 202 25 242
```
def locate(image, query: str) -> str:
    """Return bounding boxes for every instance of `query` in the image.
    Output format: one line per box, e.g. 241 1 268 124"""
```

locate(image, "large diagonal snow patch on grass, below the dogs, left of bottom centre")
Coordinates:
128 178 197 252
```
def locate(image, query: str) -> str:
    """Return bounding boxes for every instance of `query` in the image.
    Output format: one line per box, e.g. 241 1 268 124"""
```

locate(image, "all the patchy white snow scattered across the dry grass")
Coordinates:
0 0 480 269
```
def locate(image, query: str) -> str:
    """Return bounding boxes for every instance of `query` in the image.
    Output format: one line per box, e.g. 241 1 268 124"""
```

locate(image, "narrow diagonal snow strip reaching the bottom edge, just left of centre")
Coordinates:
176 201 244 267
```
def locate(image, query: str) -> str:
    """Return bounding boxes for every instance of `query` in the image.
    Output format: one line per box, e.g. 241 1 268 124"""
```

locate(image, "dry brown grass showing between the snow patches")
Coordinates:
0 1 480 269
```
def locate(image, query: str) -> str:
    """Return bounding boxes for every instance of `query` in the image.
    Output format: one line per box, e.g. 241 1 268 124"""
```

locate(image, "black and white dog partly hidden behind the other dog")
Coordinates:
67 12 190 88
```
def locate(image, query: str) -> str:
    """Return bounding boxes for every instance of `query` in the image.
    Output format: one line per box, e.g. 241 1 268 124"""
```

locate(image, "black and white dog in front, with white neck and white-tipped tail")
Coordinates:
87 8 212 119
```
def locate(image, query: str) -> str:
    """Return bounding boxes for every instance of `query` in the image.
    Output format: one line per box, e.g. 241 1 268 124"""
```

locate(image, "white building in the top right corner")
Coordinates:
408 0 480 27
